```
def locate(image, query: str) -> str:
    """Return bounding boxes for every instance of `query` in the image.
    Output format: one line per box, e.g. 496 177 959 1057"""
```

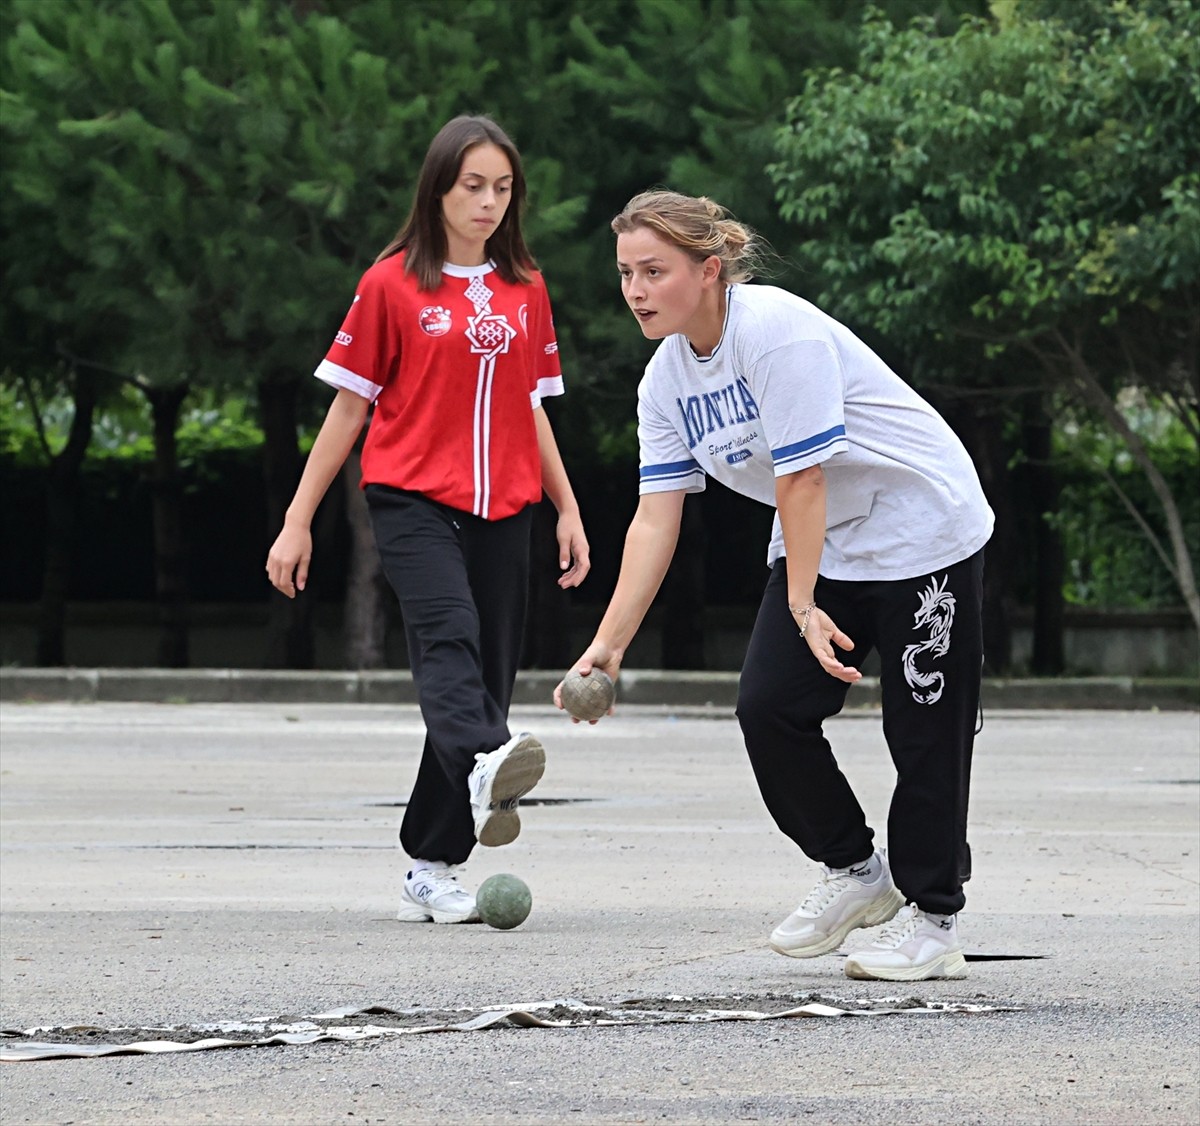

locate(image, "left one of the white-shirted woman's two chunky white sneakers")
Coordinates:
770 852 904 958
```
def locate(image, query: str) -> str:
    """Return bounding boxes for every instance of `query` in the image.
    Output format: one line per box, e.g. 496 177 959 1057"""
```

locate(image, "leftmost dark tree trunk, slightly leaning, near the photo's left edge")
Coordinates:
36 371 97 666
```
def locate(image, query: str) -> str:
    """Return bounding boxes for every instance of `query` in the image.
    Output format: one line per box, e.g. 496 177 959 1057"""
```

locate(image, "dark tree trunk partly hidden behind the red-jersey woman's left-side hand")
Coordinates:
258 378 316 669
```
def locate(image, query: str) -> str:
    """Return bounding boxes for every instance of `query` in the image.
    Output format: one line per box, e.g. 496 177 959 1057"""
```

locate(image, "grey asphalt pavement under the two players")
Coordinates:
0 696 1200 1124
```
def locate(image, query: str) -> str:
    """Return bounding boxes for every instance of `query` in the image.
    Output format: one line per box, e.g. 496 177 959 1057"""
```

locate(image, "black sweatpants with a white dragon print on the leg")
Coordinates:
738 551 983 915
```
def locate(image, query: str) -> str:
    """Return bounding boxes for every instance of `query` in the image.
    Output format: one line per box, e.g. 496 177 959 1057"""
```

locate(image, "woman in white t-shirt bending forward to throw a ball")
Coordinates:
556 191 992 980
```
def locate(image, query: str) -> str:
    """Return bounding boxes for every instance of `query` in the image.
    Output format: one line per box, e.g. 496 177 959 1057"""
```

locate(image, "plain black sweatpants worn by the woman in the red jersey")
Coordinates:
366 485 533 864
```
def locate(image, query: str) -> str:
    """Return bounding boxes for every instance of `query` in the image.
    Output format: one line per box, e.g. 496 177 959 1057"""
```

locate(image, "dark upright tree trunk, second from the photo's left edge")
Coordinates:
142 384 188 669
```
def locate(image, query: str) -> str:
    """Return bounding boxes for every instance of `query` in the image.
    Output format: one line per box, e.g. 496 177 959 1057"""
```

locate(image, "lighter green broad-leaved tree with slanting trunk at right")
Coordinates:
772 0 1200 648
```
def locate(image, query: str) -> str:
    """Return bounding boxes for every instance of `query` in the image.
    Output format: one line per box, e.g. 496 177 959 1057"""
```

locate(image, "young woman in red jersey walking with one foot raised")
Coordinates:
266 116 589 923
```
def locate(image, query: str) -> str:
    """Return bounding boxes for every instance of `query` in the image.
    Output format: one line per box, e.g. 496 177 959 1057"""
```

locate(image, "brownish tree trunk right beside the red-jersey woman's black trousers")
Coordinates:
341 439 388 669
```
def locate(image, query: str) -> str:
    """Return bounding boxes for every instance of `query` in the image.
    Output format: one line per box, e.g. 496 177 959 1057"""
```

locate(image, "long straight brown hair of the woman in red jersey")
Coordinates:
376 115 538 289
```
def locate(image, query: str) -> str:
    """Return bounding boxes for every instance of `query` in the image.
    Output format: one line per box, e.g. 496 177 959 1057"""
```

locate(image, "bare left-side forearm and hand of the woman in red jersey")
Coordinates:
266 388 370 598
